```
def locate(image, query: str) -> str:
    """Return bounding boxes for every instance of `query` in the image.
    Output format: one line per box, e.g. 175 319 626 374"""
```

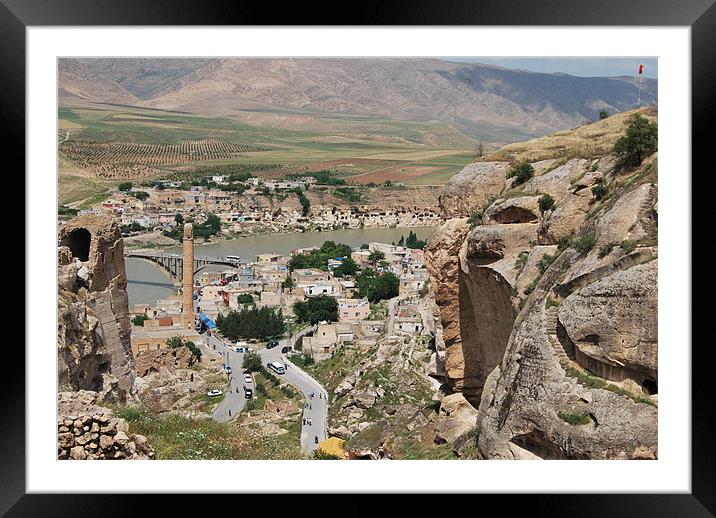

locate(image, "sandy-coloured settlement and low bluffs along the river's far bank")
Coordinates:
60 174 439 244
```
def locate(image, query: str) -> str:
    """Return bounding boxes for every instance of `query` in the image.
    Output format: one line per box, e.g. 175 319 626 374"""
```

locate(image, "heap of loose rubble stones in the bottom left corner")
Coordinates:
57 390 154 460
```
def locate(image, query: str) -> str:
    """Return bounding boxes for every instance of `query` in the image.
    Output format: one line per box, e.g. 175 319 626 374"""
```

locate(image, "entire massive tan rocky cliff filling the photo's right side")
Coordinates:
426 110 658 459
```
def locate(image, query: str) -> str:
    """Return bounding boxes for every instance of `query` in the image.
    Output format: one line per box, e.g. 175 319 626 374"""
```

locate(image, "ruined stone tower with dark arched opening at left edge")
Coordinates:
58 216 136 401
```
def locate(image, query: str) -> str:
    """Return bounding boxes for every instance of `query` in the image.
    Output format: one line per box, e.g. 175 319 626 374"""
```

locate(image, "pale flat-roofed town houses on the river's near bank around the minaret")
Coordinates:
130 238 429 360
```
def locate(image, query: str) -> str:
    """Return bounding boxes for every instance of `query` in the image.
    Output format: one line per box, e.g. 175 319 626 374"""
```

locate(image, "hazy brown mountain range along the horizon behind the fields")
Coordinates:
58 58 657 143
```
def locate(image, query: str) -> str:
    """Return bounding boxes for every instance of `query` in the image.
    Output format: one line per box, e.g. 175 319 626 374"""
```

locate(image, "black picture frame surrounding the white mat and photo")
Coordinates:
5 0 716 517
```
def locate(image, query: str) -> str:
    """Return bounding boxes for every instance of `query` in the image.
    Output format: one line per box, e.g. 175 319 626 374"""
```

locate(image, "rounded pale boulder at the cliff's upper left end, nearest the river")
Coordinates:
438 162 510 218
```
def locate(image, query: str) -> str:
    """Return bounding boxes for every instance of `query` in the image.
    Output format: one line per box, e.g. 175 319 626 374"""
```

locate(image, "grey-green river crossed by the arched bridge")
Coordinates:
125 227 435 308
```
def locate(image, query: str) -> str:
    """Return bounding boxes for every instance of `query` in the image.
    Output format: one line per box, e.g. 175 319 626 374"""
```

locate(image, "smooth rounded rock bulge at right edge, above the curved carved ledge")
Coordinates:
559 261 658 383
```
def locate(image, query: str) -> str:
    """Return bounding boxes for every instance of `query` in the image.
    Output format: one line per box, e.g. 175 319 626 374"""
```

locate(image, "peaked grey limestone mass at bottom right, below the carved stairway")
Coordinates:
478 304 657 459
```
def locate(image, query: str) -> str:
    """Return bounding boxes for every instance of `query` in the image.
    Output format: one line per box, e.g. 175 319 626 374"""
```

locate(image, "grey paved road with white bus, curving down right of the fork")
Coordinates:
258 328 328 453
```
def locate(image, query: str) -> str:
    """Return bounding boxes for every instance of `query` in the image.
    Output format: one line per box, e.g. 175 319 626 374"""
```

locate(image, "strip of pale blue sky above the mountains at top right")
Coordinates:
444 57 658 78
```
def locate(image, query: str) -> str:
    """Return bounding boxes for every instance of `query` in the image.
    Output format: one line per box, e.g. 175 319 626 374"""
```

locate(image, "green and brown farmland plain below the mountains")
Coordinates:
58 101 474 203
